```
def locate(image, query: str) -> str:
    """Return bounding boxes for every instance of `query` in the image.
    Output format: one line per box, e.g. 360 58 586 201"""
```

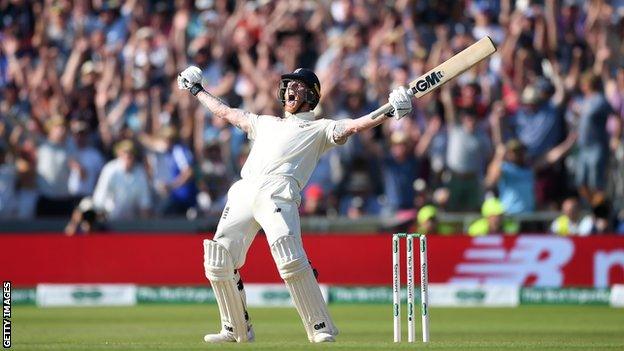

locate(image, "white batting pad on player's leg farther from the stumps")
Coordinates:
204 240 247 342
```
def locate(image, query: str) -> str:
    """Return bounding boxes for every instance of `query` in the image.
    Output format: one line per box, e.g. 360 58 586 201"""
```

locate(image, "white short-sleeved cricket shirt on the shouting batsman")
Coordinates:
241 111 338 189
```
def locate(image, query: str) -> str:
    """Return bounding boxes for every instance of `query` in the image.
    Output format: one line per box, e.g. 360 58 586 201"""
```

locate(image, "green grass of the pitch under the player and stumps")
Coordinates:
12 305 624 351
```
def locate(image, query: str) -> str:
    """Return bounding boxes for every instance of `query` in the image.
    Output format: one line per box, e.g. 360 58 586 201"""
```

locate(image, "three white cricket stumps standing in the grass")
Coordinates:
392 233 429 342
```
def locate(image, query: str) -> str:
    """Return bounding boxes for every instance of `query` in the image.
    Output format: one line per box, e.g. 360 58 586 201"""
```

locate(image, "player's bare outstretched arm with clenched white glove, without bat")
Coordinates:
178 66 251 133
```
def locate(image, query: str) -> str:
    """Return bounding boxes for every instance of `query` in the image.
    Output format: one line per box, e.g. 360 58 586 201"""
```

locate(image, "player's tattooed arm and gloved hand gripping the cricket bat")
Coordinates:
334 87 412 144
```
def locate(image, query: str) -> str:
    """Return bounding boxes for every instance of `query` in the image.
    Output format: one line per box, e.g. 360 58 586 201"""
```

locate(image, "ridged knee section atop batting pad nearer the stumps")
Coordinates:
271 235 310 280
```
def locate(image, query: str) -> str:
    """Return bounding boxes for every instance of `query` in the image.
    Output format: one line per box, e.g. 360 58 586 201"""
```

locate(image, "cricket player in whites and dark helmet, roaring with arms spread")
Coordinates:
178 66 412 343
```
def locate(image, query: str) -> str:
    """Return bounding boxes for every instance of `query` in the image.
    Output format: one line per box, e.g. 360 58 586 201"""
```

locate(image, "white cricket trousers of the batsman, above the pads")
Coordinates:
214 176 301 269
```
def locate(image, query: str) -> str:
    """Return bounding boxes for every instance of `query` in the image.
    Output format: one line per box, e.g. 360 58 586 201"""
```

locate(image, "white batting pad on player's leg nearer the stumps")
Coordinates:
271 236 338 341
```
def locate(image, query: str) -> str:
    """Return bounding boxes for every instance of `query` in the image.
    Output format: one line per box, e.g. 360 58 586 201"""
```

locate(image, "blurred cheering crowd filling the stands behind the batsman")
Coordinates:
0 0 624 235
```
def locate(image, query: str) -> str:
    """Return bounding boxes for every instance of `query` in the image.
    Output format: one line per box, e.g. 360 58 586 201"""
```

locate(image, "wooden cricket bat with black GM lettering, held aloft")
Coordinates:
368 37 496 119
